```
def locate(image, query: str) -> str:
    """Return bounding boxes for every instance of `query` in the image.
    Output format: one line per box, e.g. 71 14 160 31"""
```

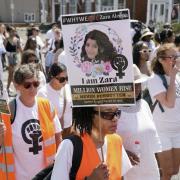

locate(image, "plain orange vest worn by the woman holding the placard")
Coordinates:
76 134 122 180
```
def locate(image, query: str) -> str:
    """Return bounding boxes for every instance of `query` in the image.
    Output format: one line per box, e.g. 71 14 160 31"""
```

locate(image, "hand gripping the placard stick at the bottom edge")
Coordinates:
86 164 109 180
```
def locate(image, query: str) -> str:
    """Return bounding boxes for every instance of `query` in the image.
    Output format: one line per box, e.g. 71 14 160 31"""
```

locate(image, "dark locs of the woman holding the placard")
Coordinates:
73 107 94 135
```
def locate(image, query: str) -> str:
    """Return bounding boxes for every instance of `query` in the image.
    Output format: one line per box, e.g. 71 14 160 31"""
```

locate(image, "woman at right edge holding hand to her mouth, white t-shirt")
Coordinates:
148 43 180 180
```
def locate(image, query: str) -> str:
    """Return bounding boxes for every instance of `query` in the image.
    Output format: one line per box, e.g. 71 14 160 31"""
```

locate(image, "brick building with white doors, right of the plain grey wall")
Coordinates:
52 0 180 24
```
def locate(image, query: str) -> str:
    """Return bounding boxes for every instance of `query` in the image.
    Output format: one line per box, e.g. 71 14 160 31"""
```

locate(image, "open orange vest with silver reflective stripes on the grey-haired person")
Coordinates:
0 97 56 180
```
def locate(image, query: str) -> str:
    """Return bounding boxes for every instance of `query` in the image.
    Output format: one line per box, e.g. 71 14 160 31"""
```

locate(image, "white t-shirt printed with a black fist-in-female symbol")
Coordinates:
11 97 62 180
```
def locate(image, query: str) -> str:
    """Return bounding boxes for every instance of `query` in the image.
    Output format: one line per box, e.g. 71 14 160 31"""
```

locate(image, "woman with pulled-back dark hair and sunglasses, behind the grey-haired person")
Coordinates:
38 63 72 135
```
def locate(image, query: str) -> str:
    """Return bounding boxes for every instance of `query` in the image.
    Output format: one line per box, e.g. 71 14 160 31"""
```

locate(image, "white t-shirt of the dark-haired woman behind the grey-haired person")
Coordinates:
38 84 72 128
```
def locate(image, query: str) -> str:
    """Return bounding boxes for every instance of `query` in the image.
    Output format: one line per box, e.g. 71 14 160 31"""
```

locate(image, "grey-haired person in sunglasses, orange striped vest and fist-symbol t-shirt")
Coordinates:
0 63 62 180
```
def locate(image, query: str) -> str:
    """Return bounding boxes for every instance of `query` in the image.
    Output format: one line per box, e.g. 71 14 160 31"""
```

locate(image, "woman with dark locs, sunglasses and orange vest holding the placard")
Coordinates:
51 106 131 180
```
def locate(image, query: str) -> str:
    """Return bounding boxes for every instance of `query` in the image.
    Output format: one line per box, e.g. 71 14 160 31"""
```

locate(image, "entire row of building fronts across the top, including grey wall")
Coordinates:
0 0 180 24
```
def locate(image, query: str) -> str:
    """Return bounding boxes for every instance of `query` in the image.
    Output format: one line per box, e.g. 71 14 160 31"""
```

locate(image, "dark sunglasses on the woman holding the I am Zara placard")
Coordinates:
94 110 121 121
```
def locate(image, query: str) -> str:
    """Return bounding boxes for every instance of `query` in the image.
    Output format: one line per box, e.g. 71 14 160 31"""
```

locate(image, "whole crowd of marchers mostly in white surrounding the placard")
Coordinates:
0 19 180 180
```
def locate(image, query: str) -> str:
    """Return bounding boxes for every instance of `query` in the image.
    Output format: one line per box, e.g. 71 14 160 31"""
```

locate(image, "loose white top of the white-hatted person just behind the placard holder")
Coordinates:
117 99 161 180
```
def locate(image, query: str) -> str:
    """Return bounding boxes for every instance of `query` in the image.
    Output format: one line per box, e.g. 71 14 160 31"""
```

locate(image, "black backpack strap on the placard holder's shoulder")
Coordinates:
65 135 83 180
